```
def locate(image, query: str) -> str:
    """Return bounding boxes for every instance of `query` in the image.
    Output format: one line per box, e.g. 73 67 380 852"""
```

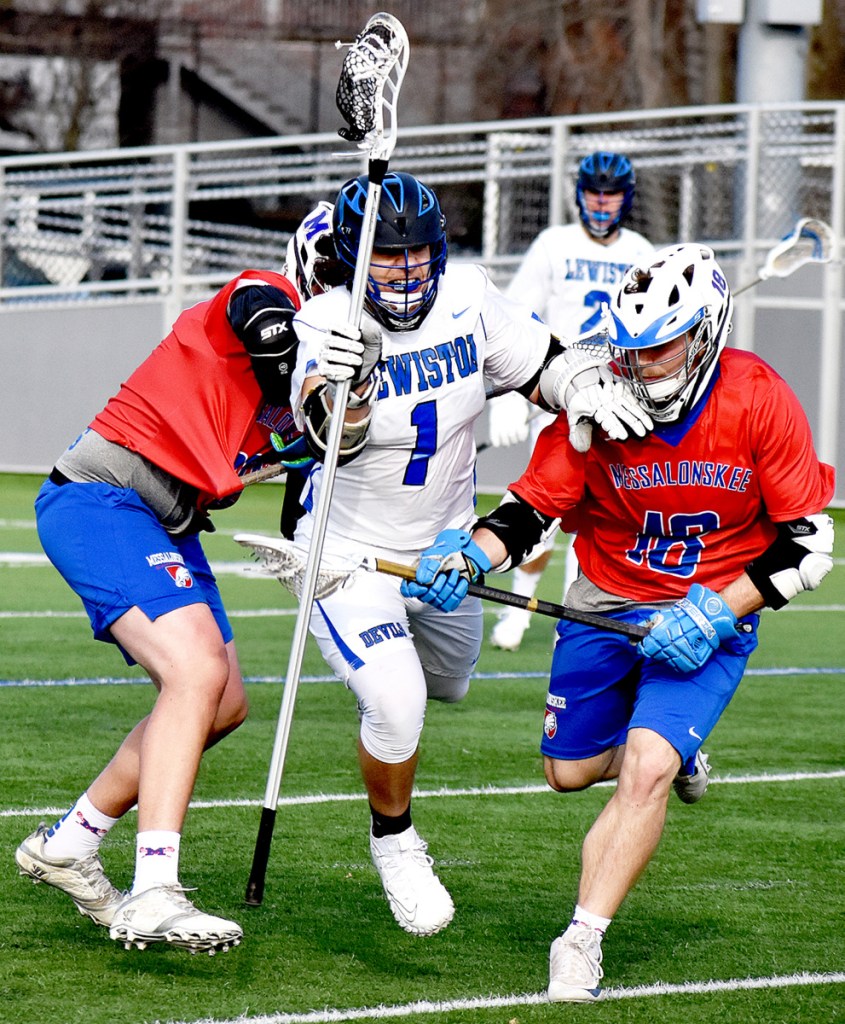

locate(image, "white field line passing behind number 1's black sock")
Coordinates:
0 768 845 818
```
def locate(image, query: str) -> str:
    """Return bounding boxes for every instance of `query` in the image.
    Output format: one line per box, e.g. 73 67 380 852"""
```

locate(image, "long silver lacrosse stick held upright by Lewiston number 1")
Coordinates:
246 13 409 906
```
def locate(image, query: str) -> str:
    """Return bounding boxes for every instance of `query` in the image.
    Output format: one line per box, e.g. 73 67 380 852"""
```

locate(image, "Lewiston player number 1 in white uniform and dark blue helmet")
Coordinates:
293 172 650 935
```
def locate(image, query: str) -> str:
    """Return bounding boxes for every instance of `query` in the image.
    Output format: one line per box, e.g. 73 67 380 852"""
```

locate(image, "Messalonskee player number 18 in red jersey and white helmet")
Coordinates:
404 245 834 1001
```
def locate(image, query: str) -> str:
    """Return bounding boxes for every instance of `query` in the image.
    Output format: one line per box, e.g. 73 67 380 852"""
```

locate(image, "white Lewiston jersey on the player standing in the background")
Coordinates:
507 222 656 341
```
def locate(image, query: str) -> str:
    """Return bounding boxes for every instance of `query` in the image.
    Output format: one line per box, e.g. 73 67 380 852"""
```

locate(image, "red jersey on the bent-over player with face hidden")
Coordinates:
91 270 300 499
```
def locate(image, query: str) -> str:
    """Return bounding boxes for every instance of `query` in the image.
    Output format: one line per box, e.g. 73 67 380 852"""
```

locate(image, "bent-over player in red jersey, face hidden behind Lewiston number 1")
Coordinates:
15 220 342 952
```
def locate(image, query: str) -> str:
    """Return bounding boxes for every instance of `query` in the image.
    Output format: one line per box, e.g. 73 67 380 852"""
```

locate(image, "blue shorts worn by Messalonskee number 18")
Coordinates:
540 608 759 763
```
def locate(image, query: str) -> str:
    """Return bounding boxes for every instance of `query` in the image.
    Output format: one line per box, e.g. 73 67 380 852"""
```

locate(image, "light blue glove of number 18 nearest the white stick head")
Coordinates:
400 529 490 611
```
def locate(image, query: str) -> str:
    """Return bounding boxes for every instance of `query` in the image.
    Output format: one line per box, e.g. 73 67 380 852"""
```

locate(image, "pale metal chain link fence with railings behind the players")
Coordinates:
0 103 845 495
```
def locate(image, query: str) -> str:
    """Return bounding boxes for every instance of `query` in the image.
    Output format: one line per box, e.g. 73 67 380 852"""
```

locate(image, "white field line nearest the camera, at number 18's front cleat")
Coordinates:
159 972 845 1024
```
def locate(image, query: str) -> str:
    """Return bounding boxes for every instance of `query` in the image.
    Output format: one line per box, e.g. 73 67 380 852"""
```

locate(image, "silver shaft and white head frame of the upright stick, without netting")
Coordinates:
246 14 409 906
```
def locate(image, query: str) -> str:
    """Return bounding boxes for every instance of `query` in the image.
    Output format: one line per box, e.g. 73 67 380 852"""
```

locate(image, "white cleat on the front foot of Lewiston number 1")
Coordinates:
370 825 455 935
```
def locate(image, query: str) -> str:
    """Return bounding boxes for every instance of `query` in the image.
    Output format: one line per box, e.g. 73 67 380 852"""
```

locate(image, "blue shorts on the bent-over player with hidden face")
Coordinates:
35 480 233 665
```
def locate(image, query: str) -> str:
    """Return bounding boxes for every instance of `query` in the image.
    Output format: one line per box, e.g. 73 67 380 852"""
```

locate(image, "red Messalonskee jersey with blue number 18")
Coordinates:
510 349 834 602
